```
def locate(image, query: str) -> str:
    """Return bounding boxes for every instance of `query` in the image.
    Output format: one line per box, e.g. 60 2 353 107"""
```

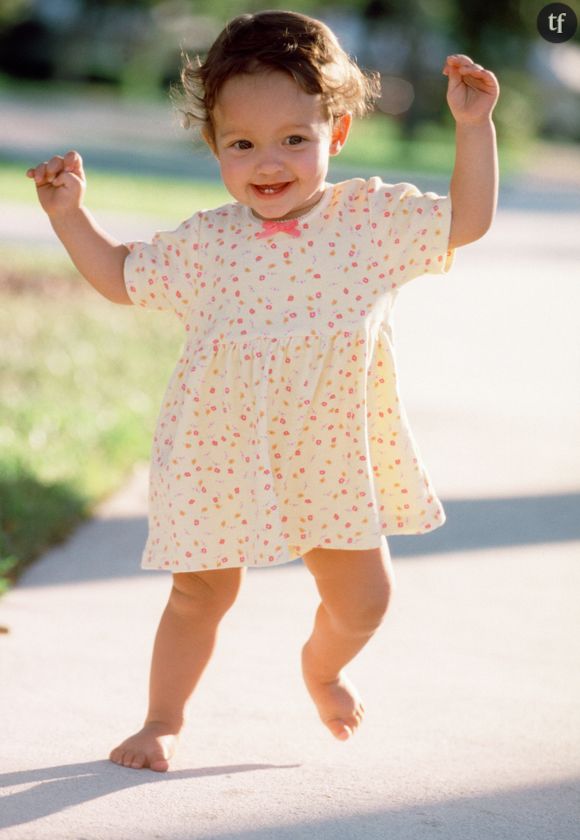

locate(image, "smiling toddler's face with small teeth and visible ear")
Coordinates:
206 71 351 219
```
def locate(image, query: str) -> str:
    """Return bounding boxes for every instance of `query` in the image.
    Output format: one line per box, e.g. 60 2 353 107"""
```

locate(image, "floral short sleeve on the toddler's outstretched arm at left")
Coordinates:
124 213 202 317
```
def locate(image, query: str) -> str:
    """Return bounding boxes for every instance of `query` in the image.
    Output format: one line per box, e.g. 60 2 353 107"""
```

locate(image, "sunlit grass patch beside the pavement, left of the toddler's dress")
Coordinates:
0 270 184 592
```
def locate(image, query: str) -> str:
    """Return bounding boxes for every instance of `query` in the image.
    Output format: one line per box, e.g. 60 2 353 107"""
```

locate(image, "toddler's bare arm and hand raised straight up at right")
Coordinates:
443 55 499 248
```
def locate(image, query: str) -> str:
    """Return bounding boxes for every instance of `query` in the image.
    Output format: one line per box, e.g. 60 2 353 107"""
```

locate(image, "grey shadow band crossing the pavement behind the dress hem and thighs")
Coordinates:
13 493 580 587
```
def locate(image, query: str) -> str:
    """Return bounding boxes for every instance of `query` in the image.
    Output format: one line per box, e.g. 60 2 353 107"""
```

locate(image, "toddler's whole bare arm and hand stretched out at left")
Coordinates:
26 152 133 304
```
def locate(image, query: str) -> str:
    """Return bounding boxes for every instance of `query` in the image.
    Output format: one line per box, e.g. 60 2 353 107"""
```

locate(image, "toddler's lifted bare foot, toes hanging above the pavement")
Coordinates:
302 643 365 741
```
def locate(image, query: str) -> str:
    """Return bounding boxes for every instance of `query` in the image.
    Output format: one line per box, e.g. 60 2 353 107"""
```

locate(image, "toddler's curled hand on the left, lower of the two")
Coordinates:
26 151 87 216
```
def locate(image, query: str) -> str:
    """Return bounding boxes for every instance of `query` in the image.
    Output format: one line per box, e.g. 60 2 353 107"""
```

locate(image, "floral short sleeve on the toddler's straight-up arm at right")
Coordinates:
367 177 455 287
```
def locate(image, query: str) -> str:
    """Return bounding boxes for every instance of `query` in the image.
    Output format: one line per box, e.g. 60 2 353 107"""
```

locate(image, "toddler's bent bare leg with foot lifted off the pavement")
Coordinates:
302 540 394 740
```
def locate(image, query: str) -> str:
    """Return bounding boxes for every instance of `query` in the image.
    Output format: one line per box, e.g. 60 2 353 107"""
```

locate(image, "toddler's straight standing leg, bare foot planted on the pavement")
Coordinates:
109 568 245 772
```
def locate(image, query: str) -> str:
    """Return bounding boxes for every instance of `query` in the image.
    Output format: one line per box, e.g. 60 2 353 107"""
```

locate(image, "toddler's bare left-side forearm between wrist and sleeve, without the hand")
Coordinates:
49 207 133 304
